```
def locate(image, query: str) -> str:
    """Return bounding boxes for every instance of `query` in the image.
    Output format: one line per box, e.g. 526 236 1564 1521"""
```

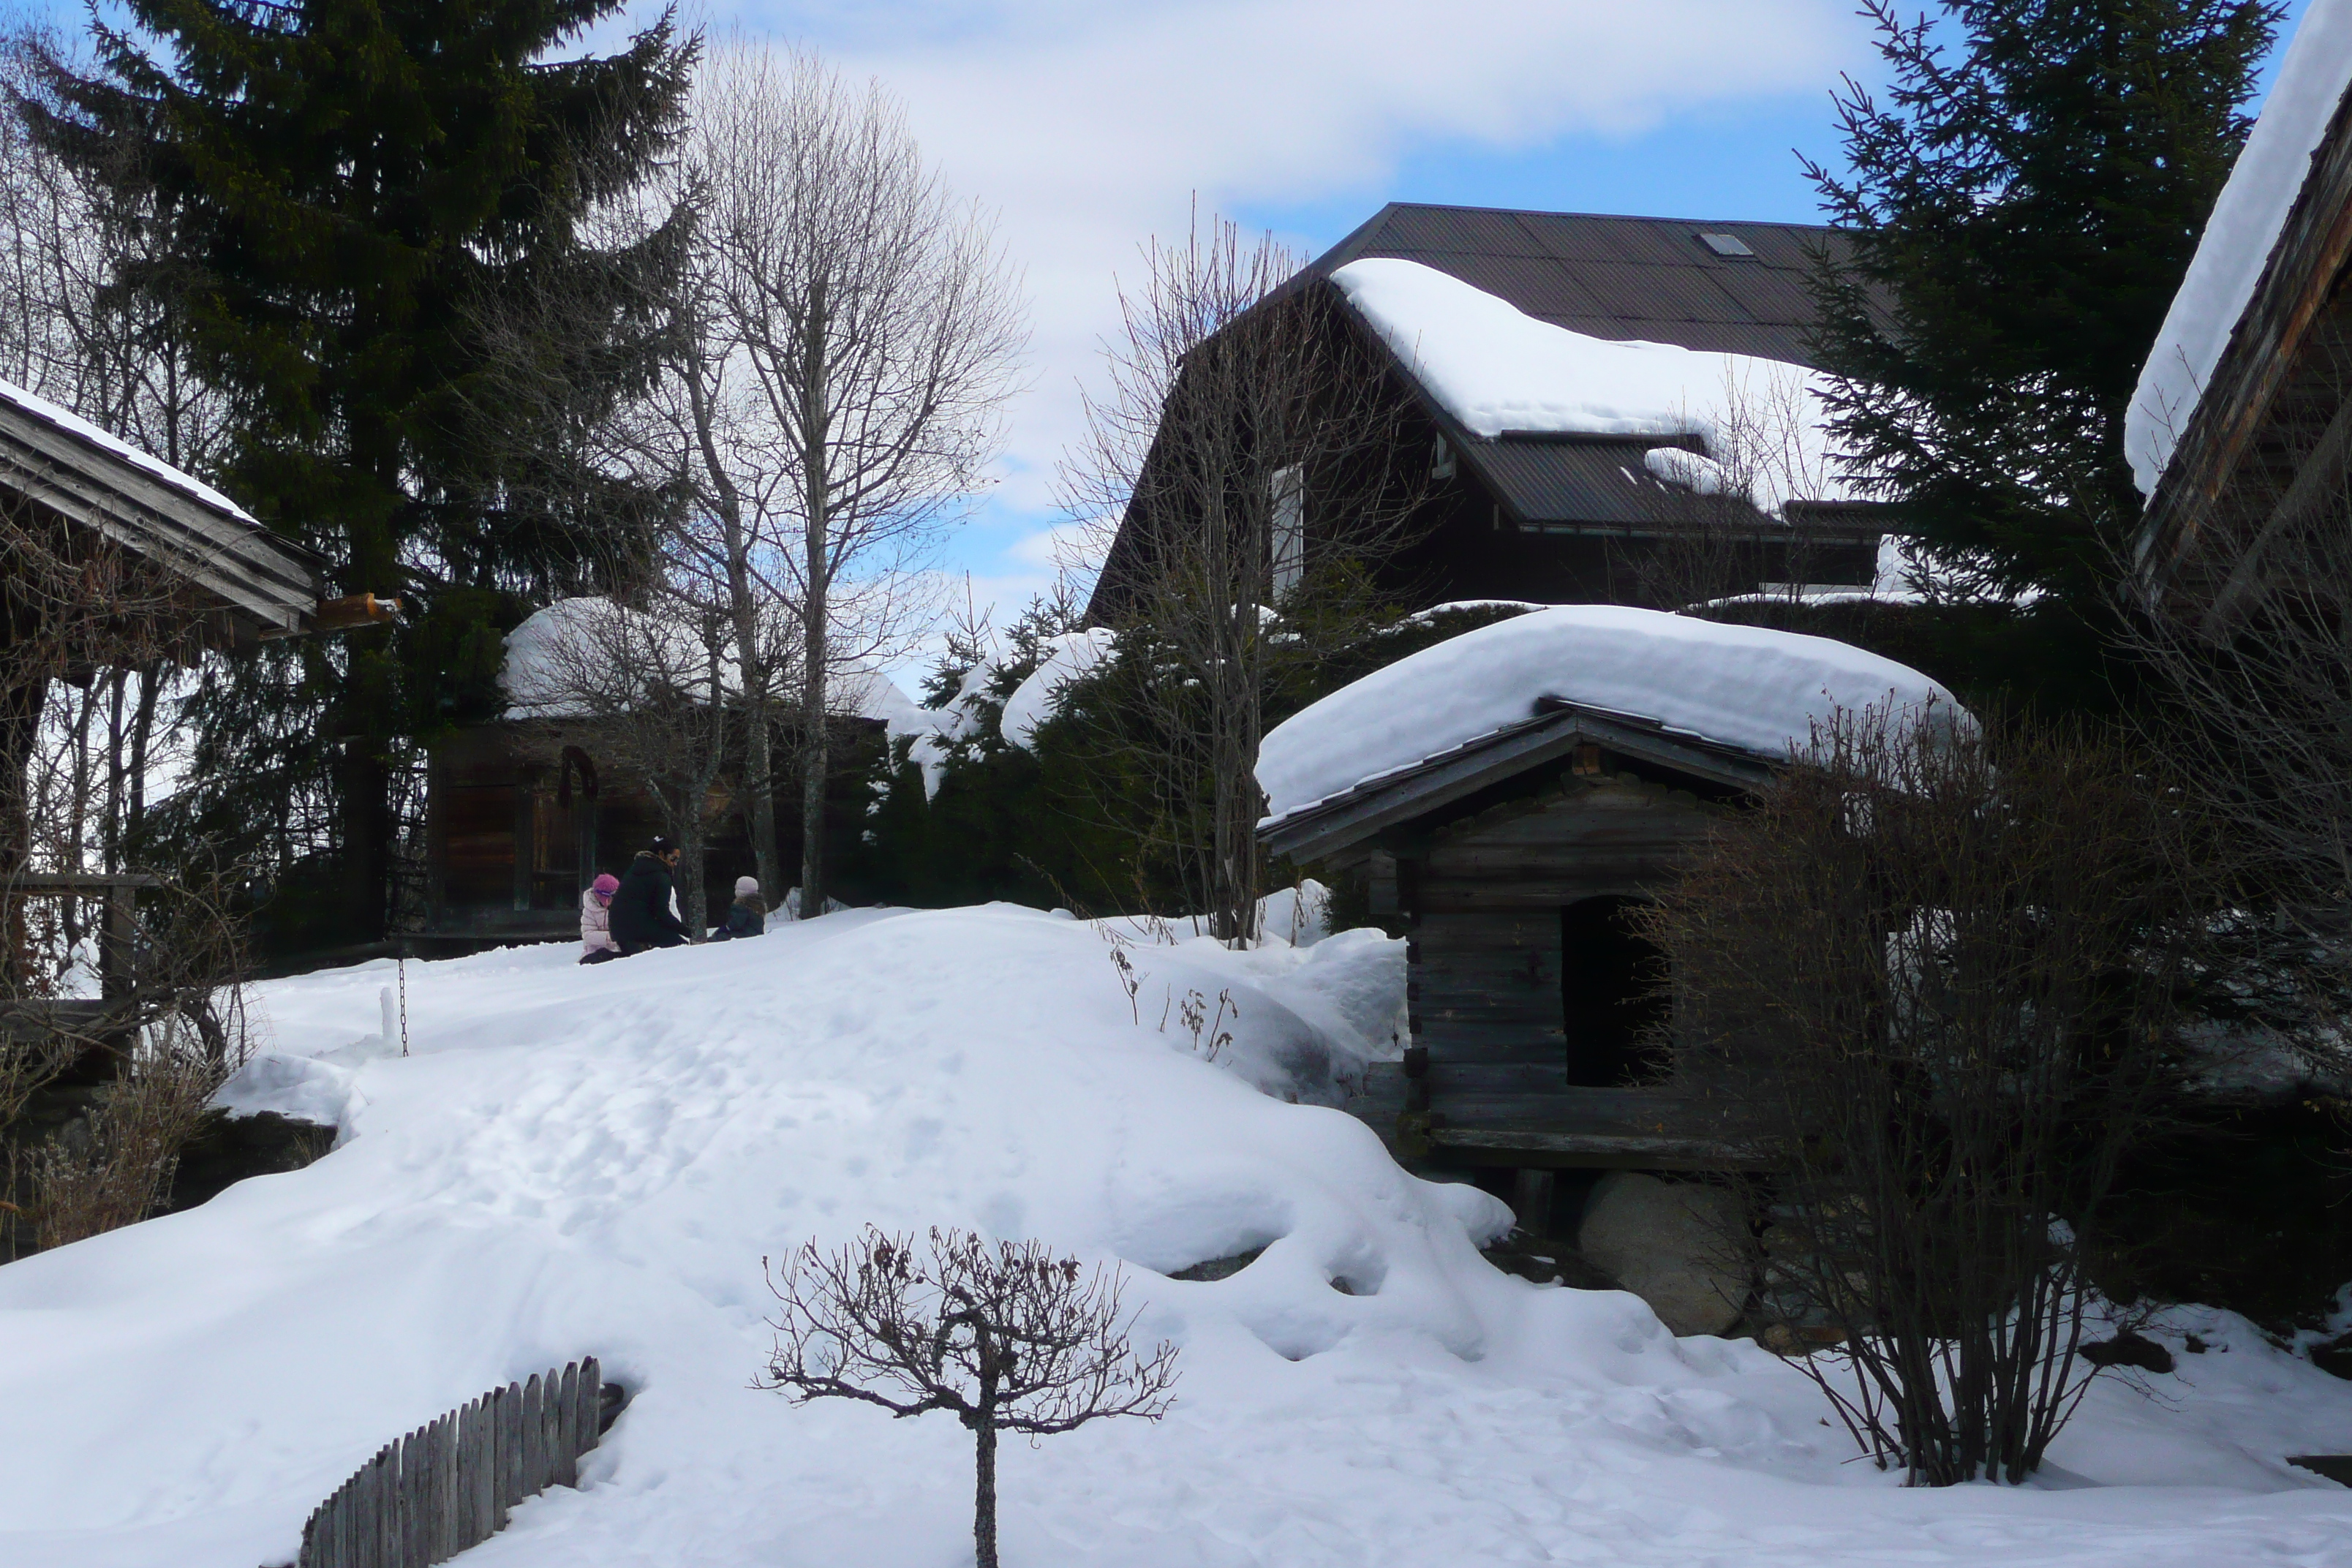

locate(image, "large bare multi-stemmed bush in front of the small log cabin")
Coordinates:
1644 712 2211 1485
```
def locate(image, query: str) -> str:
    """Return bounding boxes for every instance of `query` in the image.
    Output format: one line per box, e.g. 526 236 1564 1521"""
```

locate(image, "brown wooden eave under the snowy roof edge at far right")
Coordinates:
2133 73 2352 630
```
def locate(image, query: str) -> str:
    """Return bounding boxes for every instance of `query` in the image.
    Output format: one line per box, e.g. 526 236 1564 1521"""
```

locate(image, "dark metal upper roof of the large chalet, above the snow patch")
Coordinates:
1308 202 1849 364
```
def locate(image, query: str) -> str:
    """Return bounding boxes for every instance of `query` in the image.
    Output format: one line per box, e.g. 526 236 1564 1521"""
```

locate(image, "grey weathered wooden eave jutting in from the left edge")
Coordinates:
0 399 327 637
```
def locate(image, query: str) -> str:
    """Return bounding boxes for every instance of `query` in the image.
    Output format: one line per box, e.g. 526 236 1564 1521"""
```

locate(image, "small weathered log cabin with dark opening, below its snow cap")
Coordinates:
1263 703 1771 1189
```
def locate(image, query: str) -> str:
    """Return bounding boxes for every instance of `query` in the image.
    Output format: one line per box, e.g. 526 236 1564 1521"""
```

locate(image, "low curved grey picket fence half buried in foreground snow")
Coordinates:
296 1357 605 1568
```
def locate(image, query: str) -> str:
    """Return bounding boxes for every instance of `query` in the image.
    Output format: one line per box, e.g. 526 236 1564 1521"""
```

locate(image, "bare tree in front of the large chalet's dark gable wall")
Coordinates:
1063 219 1430 945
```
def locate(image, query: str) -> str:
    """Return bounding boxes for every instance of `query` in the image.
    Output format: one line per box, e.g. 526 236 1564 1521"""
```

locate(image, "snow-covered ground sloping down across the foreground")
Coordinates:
0 905 2352 1568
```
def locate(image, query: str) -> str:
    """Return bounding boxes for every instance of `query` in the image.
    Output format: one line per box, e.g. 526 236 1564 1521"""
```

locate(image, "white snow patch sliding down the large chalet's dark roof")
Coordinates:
1331 259 1847 517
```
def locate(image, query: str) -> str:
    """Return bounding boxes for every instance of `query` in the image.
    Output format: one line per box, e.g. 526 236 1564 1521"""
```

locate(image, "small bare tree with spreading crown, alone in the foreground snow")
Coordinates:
760 1225 1176 1568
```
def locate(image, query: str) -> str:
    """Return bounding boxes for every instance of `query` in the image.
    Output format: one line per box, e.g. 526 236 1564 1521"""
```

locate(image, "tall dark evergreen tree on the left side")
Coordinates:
17 0 694 941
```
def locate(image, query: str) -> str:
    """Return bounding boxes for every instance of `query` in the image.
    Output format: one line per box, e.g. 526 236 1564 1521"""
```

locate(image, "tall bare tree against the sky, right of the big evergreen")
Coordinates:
682 45 1025 912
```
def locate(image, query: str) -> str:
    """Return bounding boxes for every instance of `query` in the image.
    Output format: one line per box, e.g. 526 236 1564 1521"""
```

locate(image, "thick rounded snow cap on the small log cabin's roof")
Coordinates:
1259 604 1961 821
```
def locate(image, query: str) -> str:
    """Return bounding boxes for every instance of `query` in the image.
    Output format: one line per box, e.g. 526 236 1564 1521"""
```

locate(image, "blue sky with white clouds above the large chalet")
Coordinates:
29 0 2305 667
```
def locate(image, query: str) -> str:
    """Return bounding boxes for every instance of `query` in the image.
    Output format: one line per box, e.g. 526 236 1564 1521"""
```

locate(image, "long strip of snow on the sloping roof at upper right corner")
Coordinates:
2124 0 2352 496
